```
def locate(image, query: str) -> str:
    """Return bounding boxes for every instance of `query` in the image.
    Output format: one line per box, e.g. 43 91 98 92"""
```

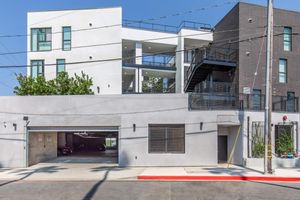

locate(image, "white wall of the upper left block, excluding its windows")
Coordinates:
27 8 122 94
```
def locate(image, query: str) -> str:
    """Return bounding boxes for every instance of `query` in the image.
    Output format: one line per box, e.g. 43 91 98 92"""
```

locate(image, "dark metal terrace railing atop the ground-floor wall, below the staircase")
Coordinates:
189 93 299 112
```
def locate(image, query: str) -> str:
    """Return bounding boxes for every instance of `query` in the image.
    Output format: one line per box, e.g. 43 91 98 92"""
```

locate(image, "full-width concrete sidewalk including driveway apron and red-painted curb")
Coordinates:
0 163 300 182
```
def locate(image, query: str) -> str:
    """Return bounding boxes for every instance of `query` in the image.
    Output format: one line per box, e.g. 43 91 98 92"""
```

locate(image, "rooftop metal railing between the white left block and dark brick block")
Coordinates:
122 19 212 33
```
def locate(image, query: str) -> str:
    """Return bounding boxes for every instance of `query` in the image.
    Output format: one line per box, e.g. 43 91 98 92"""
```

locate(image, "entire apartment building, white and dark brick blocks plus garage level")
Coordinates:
0 3 300 168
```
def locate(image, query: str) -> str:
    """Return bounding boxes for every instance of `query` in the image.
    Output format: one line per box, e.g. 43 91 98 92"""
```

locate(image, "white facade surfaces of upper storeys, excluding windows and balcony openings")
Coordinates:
27 7 212 94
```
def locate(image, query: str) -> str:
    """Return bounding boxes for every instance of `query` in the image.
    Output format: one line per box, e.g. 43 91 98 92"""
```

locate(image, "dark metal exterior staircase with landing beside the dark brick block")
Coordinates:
185 47 237 92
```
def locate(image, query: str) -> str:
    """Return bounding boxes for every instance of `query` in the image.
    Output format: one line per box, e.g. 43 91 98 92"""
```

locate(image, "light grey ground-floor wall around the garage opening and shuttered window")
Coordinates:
0 94 238 167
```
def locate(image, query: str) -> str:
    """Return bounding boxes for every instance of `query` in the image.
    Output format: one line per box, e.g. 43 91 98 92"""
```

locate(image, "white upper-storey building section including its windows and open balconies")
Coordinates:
27 7 212 94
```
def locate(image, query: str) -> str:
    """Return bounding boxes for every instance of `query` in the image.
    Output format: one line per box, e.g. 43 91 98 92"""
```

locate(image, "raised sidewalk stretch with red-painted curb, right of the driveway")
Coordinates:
138 165 300 182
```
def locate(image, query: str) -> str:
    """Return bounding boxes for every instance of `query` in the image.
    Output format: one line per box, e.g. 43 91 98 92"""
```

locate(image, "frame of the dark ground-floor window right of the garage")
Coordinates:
148 124 186 154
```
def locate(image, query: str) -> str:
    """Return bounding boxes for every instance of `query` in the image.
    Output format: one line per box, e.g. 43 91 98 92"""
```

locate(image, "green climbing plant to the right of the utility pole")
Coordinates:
275 129 294 156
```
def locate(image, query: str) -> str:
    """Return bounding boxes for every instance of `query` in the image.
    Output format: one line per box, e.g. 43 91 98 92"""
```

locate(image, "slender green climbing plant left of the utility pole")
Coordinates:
252 123 265 158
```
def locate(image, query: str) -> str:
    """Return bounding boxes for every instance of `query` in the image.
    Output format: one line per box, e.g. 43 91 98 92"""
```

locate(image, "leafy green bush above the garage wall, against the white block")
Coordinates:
14 72 94 96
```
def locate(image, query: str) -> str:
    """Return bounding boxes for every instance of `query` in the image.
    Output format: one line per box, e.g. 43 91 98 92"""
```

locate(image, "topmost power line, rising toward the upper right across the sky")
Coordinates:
0 1 236 38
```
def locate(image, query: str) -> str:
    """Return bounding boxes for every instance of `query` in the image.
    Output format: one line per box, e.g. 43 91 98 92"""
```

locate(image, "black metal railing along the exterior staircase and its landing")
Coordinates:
186 47 238 85
